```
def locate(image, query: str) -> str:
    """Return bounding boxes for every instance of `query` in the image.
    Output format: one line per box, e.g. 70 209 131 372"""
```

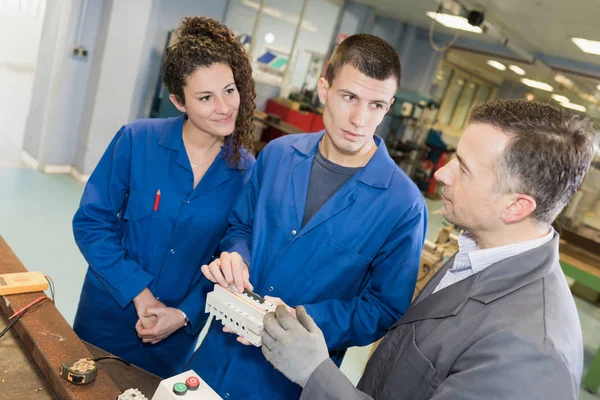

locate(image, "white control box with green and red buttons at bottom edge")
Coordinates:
152 370 223 400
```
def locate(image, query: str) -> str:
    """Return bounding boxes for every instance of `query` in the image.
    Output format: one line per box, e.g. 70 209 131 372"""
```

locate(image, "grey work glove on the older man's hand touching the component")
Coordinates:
261 305 329 387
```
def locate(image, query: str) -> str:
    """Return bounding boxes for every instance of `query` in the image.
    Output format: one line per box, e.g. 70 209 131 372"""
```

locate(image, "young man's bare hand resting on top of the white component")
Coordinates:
202 251 253 293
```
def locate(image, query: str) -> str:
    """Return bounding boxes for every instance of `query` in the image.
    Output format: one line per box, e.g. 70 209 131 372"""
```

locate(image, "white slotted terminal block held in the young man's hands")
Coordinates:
205 284 275 347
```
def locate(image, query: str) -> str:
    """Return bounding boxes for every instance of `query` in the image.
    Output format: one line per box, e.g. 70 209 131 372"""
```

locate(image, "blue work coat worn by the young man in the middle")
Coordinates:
186 133 427 400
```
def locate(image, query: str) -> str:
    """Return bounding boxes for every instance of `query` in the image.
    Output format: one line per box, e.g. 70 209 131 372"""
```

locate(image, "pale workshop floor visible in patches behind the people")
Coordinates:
0 130 600 400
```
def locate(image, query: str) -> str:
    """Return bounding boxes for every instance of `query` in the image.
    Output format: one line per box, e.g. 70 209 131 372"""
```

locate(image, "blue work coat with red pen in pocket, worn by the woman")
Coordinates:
73 116 254 377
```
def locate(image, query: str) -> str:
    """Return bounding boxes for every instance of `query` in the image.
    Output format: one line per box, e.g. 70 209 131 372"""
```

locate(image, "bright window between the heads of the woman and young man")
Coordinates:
224 0 343 90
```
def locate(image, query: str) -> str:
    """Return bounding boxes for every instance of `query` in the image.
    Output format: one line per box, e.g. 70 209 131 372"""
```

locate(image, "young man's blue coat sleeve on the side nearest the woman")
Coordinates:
219 148 267 267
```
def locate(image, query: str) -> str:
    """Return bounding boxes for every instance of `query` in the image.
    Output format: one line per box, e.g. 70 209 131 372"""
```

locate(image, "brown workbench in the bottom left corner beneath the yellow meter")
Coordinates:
0 236 161 400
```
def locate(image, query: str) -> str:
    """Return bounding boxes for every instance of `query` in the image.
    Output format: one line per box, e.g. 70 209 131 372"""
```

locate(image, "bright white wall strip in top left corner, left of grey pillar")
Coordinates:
0 0 46 148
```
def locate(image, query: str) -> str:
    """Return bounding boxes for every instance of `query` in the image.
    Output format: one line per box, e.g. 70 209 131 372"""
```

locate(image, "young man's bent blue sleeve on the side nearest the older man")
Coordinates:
305 200 427 351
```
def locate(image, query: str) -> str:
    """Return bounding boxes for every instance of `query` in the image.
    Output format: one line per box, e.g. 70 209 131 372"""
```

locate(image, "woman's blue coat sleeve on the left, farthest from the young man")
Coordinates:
73 127 153 308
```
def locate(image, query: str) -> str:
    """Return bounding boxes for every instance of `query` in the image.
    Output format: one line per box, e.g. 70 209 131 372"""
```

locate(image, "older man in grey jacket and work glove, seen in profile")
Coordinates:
262 100 594 400
